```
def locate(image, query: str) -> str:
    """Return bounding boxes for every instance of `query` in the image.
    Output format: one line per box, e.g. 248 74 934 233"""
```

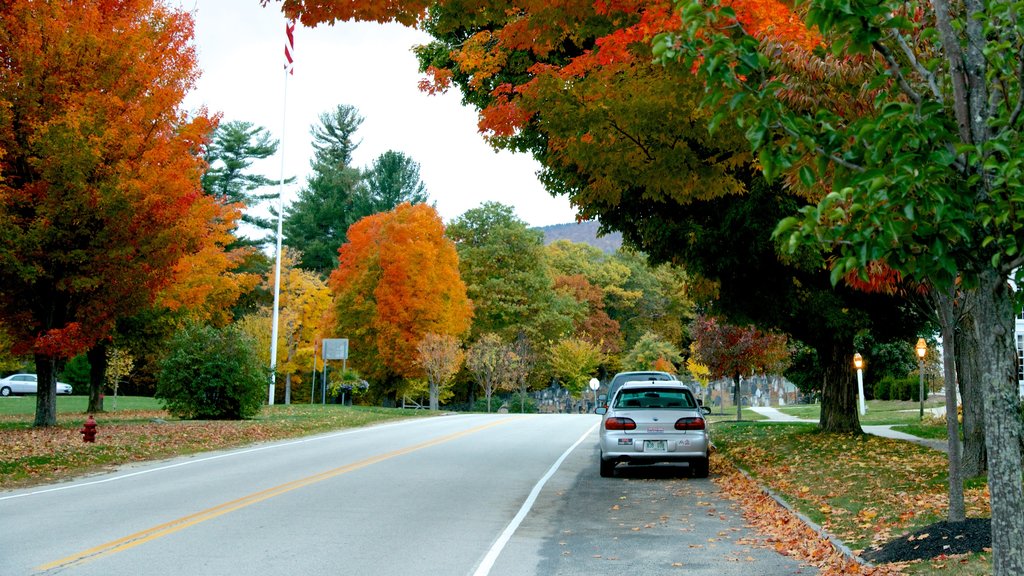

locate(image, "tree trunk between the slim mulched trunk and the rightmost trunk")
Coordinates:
947 303 986 478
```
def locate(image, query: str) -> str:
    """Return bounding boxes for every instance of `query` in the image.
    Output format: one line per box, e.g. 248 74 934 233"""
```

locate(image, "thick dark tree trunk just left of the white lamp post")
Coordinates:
818 342 863 434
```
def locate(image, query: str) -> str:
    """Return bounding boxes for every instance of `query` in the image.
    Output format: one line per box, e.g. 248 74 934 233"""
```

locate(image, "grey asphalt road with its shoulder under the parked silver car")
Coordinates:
0 415 814 576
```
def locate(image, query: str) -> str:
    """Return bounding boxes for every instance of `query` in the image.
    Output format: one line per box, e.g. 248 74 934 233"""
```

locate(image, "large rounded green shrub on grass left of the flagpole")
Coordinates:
156 325 270 420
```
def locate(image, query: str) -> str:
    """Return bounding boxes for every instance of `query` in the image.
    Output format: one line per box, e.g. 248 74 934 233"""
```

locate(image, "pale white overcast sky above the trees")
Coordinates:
171 0 575 227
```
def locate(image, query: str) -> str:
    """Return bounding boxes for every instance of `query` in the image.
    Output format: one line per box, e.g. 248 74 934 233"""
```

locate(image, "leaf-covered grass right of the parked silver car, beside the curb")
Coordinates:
712 422 990 575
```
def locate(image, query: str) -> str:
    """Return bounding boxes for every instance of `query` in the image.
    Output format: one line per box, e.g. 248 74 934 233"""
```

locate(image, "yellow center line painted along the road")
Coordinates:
36 418 513 572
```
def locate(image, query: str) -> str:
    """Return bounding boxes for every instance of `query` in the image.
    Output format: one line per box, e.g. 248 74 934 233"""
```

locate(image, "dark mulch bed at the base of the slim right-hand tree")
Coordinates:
861 518 992 564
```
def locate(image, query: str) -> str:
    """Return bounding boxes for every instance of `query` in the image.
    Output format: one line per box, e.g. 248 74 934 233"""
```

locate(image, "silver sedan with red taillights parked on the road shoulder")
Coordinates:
596 380 711 478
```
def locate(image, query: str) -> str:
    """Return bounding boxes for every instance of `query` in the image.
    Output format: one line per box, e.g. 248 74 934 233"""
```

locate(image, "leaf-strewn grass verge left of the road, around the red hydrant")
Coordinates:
0 397 430 489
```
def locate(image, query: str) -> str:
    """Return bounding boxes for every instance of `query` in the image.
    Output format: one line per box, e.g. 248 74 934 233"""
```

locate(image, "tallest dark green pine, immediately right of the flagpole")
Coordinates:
283 105 364 276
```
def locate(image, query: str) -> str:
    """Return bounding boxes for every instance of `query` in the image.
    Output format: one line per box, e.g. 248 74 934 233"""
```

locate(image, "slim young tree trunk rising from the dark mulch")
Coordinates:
932 288 967 522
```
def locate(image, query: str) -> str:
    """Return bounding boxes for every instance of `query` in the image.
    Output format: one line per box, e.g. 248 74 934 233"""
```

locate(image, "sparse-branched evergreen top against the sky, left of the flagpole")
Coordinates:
202 120 286 246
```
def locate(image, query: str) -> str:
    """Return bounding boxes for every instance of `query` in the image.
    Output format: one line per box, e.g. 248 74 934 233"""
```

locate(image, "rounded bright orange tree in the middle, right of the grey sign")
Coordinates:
329 204 472 404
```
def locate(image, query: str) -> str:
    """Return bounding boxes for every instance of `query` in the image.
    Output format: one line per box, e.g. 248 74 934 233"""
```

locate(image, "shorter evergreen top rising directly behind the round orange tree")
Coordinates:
352 150 427 219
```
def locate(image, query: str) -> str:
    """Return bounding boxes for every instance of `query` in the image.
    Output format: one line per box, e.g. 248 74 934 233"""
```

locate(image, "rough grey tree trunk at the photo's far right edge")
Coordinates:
974 270 1024 576
